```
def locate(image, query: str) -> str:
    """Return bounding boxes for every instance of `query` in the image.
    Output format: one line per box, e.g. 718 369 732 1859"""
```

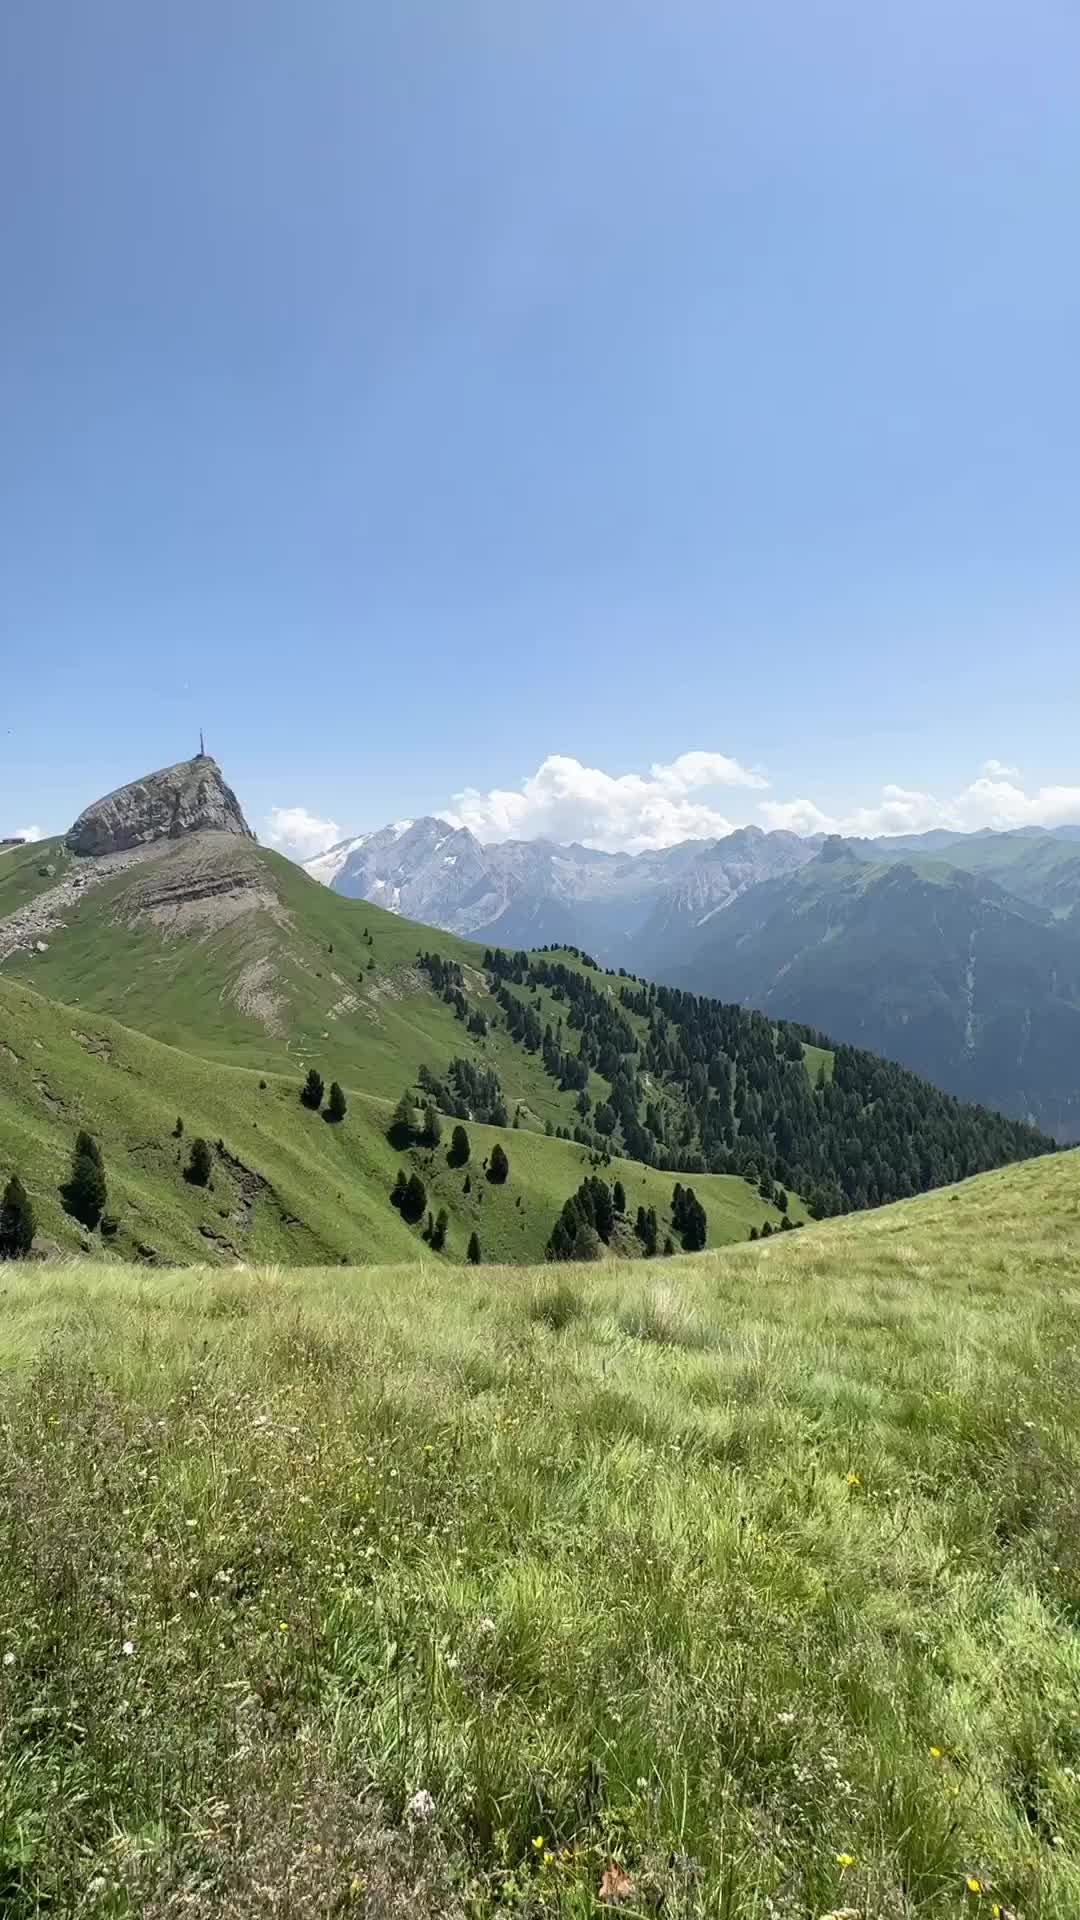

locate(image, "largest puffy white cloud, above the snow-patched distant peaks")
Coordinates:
444 751 769 852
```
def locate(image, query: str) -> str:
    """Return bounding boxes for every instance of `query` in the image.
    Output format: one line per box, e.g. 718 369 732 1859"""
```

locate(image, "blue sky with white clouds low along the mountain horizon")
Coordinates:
0 0 1080 843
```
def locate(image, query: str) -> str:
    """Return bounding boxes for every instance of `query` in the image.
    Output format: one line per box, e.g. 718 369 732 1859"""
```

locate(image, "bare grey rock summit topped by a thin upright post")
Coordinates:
67 755 256 854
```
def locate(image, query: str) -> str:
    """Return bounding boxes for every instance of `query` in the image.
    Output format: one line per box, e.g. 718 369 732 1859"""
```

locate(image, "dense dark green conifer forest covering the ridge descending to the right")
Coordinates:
472 950 1055 1219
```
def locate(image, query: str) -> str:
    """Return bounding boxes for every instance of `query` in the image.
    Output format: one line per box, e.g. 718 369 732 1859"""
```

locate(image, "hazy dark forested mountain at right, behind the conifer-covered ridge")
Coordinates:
667 845 1080 1140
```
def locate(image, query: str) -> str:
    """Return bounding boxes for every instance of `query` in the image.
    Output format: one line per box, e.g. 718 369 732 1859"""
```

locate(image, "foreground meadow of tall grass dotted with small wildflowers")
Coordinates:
0 1156 1080 1920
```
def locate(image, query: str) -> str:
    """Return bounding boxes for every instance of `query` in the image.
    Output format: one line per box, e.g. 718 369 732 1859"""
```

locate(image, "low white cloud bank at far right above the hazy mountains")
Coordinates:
759 775 1080 837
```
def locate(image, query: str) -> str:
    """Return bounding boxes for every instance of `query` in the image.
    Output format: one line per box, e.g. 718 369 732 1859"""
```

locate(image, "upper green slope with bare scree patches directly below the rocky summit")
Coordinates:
0 835 664 1129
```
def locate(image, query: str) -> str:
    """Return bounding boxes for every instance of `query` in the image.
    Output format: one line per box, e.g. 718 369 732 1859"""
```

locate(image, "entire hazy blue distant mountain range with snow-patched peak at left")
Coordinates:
307 816 1080 1140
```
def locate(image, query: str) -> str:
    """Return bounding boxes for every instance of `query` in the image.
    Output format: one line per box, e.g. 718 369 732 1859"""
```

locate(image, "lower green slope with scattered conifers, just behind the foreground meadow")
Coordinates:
0 975 801 1263
